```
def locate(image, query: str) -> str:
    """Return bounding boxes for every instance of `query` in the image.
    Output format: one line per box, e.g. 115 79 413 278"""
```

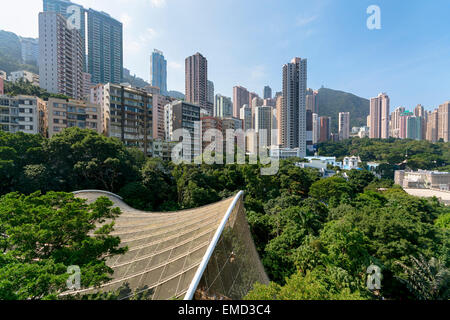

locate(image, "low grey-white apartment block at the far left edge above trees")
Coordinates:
0 94 46 136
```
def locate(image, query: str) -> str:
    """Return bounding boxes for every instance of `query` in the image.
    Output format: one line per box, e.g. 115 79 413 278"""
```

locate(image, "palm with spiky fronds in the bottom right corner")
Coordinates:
396 255 450 300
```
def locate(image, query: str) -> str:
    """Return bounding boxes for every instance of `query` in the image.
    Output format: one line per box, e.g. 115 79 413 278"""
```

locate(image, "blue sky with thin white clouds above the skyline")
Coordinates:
0 0 450 109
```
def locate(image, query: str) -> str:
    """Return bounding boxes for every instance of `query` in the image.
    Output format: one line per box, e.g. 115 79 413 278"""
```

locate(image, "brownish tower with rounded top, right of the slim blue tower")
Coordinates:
185 52 213 115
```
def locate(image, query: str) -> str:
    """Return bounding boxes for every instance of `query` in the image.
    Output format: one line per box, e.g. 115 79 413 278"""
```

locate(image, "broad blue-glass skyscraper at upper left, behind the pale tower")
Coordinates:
87 9 123 84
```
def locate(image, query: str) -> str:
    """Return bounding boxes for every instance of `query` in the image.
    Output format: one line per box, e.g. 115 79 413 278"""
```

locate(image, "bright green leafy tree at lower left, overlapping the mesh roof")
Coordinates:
0 192 126 300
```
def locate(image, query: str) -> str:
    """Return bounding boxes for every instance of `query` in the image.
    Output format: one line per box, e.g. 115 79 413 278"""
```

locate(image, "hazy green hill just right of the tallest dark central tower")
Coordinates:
318 88 370 132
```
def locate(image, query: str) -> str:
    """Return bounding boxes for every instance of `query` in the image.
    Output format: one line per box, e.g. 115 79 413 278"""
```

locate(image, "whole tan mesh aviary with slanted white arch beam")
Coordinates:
68 190 269 300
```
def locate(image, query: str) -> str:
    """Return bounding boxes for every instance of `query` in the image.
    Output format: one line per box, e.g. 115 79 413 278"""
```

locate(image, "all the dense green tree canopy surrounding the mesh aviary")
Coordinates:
0 128 450 299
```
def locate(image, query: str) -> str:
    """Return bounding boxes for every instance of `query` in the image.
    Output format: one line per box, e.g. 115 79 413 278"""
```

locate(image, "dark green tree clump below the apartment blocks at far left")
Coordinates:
0 128 138 194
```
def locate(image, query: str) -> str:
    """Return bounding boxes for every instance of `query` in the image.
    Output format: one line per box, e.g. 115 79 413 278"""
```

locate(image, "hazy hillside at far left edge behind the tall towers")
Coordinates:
0 30 39 74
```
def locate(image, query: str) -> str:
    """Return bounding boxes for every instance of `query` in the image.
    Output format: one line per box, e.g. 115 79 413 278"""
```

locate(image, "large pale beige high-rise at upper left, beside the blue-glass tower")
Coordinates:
39 12 84 99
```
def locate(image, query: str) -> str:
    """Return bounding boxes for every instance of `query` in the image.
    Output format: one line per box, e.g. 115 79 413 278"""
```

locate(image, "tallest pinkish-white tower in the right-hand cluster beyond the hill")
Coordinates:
370 93 390 139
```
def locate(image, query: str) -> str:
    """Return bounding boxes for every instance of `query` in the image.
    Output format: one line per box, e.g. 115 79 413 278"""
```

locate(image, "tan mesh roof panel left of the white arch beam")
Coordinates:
71 192 233 300
